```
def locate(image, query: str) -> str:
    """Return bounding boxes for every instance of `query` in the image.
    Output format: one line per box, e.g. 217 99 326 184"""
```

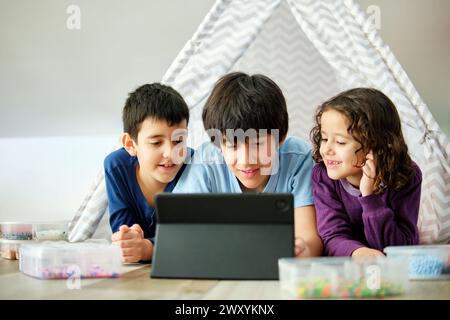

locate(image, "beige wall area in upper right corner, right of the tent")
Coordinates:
356 0 450 136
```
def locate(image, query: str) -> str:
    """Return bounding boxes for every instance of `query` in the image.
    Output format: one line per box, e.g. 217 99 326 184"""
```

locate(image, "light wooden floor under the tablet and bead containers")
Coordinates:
0 259 450 300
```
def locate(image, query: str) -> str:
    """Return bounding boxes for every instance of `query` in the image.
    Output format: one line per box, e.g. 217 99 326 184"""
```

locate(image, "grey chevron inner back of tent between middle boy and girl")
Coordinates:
232 1 340 141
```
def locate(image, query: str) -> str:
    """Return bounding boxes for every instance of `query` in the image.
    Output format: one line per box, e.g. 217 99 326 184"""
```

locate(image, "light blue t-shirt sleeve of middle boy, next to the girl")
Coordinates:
291 143 314 208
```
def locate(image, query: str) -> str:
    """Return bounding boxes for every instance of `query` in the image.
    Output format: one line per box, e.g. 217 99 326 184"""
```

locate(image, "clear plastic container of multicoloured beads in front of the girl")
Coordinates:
278 257 407 299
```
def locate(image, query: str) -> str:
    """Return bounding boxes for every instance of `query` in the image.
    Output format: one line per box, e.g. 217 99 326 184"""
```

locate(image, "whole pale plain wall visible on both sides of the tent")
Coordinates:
0 0 450 221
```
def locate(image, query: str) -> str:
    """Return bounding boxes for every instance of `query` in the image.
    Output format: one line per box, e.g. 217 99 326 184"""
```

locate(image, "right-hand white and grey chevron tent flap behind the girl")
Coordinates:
288 0 450 243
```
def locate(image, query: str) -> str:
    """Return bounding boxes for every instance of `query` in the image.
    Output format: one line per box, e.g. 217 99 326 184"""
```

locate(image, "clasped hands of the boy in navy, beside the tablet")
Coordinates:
111 224 153 263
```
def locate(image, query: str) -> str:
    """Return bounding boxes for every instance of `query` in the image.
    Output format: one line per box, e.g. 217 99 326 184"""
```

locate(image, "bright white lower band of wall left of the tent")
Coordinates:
0 136 118 221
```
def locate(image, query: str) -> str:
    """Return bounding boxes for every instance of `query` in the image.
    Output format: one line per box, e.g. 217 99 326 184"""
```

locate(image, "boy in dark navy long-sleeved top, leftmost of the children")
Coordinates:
104 83 191 262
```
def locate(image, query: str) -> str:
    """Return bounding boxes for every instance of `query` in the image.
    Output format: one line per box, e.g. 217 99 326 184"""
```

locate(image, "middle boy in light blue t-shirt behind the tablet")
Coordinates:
173 72 322 256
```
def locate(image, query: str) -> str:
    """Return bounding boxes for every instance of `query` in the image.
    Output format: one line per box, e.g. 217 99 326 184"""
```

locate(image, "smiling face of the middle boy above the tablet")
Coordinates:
220 134 278 192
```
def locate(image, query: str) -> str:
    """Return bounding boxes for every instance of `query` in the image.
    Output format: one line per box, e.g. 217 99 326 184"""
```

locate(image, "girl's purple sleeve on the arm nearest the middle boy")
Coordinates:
312 164 365 256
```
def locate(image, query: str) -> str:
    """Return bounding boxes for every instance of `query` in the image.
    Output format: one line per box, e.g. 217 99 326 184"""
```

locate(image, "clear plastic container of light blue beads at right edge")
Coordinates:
384 244 450 280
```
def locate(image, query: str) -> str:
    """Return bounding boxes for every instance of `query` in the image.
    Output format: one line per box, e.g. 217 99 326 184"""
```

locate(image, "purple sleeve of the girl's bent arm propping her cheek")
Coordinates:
358 165 422 251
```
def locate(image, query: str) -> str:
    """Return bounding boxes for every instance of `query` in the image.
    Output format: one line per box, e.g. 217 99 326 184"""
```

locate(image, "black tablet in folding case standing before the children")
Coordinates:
151 193 294 280
